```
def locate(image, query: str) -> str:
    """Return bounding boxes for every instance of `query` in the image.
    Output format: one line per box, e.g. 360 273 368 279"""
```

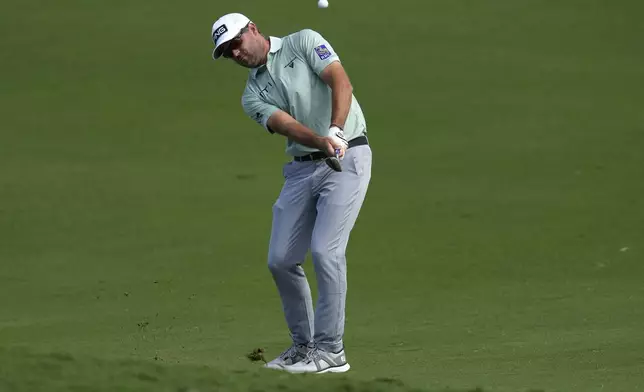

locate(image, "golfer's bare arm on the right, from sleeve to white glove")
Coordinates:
320 61 353 129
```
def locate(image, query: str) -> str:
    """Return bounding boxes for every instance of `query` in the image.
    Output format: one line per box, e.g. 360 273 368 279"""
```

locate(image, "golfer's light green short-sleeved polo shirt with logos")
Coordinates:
242 30 367 156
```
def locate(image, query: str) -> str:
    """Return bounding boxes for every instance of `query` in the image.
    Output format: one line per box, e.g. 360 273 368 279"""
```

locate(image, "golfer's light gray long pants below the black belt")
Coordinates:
268 145 371 352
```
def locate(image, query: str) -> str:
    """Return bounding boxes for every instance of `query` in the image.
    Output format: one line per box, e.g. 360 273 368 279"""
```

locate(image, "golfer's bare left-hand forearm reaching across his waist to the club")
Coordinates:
266 110 342 156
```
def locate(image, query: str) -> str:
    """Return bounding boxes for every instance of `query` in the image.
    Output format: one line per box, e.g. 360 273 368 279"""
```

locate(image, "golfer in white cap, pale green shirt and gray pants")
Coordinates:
212 13 371 373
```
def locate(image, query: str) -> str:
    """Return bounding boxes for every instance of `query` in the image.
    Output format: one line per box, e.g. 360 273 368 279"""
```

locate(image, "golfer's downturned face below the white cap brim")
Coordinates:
222 23 266 68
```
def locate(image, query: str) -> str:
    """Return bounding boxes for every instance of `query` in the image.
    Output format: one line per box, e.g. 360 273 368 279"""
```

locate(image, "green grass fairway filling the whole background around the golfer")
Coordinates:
0 0 644 392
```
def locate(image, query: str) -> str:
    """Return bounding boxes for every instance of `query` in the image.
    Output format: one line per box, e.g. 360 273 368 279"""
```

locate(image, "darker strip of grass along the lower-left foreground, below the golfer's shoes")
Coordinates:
0 350 452 392
